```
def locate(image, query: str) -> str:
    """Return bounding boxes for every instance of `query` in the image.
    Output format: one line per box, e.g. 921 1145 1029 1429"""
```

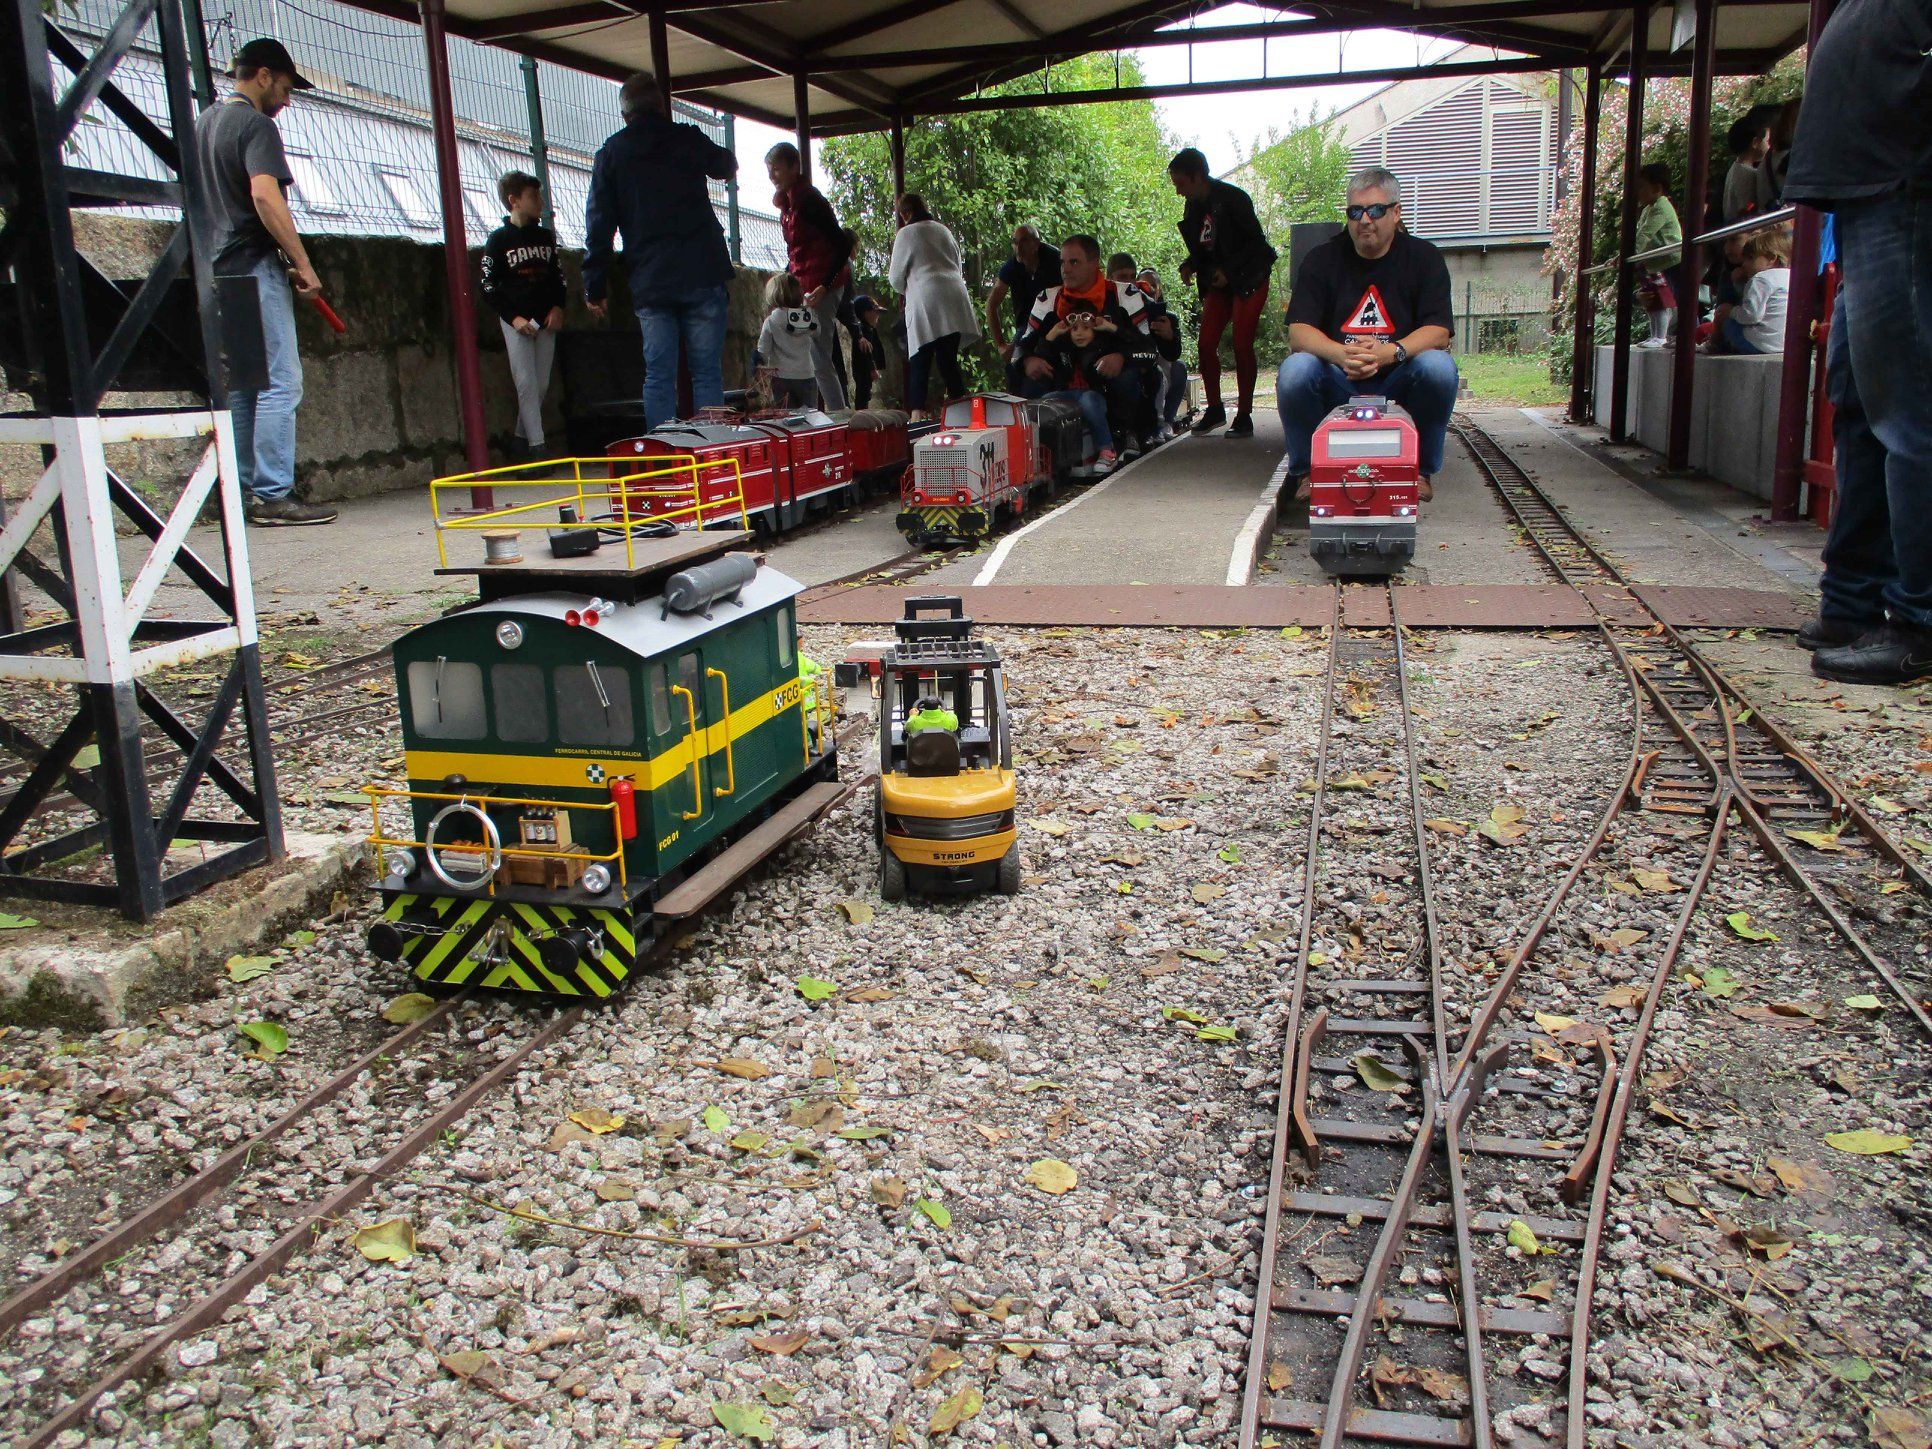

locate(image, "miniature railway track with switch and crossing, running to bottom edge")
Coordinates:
1240 589 1729 1449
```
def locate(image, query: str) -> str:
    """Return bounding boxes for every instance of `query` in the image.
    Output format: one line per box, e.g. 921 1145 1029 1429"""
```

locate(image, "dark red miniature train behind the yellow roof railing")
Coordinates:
607 410 908 533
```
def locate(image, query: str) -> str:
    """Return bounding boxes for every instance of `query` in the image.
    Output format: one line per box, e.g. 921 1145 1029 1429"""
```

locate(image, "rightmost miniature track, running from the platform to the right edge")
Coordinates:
1455 415 1932 1036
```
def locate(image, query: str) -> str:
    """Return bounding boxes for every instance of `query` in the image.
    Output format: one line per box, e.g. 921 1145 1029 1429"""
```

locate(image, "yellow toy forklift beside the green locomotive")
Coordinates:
873 595 1020 900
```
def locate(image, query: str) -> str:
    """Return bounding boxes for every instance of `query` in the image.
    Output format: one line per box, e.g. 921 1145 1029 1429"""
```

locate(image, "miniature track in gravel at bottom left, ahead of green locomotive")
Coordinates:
0 995 583 1449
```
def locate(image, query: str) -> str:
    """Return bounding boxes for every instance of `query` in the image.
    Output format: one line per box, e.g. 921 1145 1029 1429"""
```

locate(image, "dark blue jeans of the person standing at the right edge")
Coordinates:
1818 195 1932 628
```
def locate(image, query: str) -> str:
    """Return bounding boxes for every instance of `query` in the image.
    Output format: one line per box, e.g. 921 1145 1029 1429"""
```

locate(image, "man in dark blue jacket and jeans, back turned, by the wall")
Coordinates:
583 73 738 427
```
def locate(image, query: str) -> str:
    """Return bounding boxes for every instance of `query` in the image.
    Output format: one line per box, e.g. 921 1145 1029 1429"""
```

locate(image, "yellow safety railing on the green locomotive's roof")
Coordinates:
429 458 752 568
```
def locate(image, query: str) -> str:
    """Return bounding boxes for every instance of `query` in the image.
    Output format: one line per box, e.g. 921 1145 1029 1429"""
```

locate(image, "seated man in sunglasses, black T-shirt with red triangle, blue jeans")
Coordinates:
1275 166 1457 502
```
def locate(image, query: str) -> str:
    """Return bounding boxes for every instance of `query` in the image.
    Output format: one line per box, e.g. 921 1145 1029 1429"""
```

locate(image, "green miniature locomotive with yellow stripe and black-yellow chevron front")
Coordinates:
367 531 842 997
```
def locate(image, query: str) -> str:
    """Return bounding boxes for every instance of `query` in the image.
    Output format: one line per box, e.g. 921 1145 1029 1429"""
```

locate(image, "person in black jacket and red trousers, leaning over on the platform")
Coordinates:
1167 147 1275 439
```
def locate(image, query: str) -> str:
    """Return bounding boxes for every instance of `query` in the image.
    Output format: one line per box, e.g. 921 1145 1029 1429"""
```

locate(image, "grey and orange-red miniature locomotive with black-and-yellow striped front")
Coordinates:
896 392 1094 547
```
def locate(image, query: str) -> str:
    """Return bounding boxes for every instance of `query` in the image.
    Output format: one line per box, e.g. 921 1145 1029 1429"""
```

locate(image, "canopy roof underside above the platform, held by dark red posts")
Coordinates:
350 0 1808 135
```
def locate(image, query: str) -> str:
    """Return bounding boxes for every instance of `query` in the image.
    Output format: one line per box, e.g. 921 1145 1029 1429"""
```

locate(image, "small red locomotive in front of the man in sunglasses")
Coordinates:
1308 396 1422 576
